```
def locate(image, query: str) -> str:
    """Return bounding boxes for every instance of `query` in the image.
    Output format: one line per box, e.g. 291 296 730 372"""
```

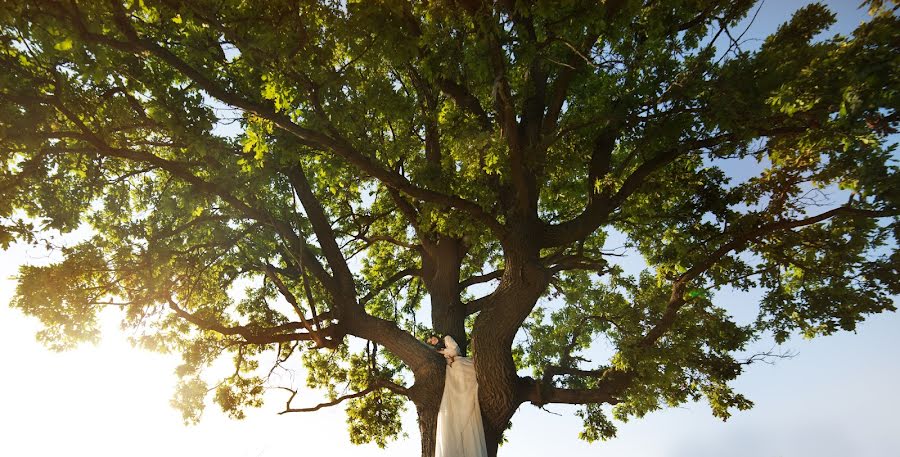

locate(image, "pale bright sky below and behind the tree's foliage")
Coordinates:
0 0 900 457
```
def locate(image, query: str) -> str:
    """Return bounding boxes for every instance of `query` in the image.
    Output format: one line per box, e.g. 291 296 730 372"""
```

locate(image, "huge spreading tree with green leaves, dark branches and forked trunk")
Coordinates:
0 0 900 456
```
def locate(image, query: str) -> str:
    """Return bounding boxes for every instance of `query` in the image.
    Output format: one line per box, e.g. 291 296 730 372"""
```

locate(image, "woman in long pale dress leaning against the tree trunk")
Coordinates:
435 335 487 457
